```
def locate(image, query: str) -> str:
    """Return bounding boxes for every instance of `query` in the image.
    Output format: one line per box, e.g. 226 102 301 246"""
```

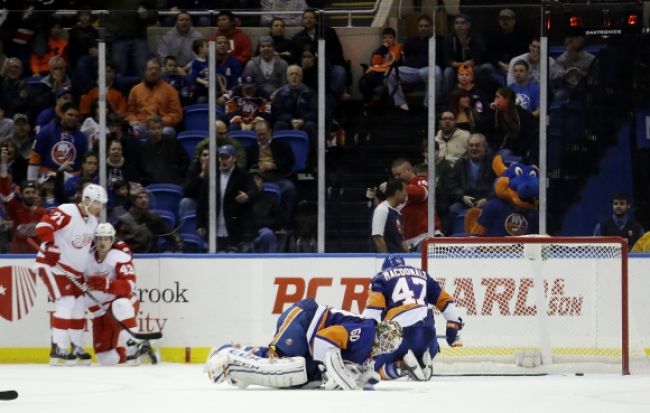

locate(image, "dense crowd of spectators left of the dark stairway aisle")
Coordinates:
0 4 334 252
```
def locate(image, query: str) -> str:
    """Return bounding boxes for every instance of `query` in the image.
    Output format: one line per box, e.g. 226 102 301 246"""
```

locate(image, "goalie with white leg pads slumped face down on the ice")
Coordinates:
205 299 402 390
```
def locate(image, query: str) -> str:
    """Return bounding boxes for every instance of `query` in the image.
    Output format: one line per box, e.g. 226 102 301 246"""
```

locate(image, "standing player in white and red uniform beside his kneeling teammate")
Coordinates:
34 184 108 365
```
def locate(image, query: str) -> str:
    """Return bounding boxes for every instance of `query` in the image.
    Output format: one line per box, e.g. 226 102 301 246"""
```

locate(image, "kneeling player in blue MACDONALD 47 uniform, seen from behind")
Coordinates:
362 255 463 381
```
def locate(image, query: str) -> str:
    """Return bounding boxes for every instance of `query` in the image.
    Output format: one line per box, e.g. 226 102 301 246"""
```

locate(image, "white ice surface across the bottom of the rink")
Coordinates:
0 363 650 413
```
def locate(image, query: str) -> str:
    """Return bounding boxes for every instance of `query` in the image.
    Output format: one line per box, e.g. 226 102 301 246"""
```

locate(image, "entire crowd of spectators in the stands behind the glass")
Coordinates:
0 4 636 252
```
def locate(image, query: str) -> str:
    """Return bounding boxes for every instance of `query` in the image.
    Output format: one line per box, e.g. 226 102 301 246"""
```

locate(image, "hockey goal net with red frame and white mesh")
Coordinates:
422 237 650 374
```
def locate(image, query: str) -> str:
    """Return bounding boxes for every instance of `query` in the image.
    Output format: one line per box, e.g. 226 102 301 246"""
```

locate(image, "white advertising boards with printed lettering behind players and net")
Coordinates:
0 255 650 349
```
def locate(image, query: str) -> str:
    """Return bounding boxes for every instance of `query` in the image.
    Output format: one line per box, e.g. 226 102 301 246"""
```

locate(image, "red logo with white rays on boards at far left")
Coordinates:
0 267 36 321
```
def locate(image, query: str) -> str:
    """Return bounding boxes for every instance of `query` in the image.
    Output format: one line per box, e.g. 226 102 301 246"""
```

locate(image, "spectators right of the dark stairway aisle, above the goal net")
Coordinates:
359 9 612 252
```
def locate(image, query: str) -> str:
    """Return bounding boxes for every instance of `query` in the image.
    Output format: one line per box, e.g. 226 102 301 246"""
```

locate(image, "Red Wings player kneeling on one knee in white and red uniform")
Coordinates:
84 223 157 366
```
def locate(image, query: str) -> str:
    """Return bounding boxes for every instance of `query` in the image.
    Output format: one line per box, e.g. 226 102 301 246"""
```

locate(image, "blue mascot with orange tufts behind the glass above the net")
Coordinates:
465 155 539 237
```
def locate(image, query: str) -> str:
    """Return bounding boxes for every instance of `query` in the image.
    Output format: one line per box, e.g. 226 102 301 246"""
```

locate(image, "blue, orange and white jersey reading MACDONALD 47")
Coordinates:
362 265 458 327
